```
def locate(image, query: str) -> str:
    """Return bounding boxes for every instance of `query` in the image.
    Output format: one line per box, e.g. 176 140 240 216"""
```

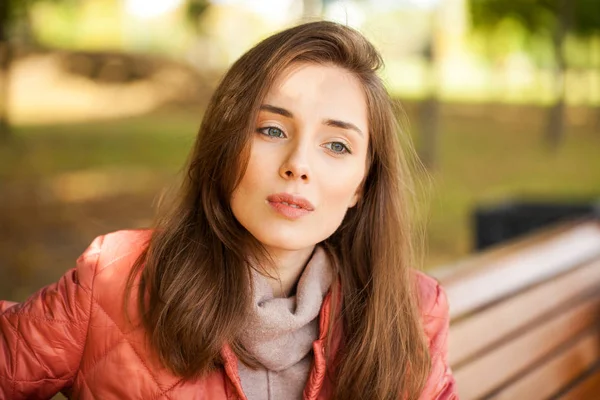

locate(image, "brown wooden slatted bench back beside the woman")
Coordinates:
431 219 600 400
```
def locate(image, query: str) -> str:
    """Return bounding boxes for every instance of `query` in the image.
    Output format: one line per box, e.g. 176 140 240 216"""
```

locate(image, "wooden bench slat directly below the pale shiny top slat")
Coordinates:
448 260 600 367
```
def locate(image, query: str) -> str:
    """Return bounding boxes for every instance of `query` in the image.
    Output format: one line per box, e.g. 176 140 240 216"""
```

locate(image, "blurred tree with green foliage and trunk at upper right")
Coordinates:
469 0 600 148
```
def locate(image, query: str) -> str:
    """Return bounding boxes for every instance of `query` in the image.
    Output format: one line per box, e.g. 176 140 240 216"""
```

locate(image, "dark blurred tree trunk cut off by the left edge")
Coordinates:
0 0 12 142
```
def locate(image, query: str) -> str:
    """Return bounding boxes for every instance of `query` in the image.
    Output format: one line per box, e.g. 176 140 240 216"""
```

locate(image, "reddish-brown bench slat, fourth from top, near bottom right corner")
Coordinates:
491 329 600 400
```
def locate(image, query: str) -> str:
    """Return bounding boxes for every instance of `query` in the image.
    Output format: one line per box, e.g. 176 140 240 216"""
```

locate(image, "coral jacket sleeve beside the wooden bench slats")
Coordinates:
420 278 458 400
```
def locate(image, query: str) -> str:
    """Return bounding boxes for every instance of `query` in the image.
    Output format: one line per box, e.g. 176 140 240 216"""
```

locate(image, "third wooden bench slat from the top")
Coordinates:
454 297 600 400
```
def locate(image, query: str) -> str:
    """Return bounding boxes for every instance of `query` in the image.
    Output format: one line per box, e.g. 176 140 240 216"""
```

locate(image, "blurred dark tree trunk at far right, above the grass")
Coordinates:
546 0 573 151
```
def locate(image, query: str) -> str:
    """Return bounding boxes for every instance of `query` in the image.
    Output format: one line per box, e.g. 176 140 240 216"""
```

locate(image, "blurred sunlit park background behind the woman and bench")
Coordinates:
0 0 600 300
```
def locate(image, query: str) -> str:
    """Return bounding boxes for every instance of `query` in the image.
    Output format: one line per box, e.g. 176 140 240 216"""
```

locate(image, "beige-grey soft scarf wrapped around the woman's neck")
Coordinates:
238 246 333 400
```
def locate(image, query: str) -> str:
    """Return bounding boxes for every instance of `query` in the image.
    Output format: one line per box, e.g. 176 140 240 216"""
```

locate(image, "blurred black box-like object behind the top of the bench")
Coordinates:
474 200 600 251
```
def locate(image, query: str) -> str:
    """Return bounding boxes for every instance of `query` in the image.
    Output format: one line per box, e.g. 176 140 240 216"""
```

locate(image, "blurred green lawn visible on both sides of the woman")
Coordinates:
0 105 600 267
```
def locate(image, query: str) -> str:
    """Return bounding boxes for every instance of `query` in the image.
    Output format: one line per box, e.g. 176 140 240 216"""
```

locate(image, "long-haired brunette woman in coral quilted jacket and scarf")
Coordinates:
0 22 456 400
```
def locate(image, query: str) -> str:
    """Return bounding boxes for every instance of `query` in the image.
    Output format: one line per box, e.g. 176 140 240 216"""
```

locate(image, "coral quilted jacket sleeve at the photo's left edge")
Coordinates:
0 238 102 400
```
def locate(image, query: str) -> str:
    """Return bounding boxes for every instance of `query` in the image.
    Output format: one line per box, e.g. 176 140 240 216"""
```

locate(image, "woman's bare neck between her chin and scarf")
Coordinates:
265 246 315 297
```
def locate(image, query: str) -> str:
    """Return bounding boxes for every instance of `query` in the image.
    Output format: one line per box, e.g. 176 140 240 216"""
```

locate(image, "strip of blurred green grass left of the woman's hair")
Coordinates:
0 110 200 178
